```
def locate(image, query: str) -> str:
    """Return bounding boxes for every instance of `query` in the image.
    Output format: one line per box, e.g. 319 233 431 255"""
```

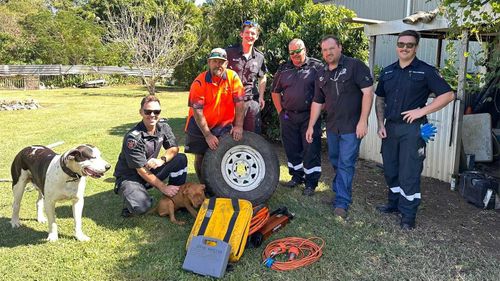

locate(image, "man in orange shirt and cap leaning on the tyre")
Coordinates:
185 48 245 183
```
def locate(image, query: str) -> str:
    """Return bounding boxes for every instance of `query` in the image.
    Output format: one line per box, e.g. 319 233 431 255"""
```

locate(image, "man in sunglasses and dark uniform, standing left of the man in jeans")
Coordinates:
271 39 323 196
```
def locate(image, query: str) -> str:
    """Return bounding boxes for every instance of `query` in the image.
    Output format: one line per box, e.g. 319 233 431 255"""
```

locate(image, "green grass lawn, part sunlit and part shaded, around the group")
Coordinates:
0 87 500 280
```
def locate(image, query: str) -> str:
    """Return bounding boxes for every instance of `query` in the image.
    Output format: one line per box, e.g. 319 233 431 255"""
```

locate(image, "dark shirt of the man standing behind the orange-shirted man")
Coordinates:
226 44 267 98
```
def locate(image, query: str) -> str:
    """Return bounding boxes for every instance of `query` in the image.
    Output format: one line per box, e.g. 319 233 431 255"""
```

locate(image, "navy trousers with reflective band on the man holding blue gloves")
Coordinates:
382 121 425 224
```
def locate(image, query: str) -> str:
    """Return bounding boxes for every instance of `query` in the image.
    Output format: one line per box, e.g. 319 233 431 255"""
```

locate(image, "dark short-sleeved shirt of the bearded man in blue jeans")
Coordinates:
314 55 373 134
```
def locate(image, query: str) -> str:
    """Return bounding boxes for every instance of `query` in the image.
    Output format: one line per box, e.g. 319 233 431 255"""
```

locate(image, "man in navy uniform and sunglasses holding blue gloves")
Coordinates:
375 30 455 230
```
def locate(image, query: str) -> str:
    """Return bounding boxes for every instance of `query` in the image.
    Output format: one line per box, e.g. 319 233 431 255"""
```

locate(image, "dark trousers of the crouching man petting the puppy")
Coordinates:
116 153 187 215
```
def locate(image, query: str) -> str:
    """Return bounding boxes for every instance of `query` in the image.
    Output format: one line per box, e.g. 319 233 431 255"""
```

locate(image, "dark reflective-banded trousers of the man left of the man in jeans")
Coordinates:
279 110 321 188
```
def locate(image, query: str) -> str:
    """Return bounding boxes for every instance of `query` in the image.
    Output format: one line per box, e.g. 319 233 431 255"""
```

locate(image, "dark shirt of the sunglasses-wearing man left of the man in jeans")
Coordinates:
271 57 323 112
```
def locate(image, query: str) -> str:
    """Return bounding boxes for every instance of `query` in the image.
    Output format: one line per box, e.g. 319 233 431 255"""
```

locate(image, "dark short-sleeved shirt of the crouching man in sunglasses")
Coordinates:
113 119 177 179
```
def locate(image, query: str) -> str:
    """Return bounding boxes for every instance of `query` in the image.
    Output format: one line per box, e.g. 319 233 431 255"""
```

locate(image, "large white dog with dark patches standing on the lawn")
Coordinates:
10 144 111 241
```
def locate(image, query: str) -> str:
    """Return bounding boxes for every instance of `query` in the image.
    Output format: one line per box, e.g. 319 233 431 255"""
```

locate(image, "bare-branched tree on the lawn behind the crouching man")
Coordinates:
108 3 201 94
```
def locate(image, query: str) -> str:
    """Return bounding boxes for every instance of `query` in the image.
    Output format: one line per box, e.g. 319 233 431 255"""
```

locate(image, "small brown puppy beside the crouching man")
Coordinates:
150 183 206 225
